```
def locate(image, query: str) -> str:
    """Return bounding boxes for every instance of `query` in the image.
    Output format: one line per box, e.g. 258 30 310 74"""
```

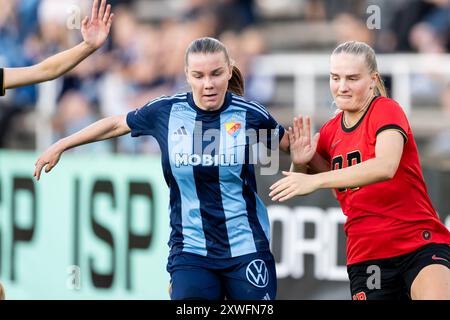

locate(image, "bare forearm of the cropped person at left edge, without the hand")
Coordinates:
4 41 95 89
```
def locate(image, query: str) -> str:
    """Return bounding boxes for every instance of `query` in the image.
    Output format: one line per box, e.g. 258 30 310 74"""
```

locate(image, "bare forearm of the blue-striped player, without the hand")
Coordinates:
57 116 130 151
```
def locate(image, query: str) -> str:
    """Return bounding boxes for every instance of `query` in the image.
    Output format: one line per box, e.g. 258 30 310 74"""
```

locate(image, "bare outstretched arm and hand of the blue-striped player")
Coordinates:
33 115 131 180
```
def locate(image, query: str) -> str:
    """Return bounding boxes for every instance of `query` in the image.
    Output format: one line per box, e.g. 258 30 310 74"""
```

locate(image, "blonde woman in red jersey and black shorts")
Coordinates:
269 42 450 299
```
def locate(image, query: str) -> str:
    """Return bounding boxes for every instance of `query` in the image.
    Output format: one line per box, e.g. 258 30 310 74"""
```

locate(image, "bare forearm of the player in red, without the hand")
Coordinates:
315 158 396 189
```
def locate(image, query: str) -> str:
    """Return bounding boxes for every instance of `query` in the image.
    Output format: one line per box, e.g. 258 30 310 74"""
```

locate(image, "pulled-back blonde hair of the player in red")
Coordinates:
331 41 388 97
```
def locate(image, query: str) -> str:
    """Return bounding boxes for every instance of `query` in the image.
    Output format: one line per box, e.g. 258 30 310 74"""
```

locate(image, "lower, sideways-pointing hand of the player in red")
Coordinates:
269 171 319 202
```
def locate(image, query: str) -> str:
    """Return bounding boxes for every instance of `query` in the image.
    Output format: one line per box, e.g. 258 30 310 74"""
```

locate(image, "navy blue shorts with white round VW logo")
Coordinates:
167 252 277 300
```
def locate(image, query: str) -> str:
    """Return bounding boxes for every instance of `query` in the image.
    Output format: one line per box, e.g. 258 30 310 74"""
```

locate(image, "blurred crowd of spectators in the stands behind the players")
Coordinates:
0 0 450 157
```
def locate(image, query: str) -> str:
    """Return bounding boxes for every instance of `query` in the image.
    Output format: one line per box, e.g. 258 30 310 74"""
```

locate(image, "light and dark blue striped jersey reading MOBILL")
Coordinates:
127 92 284 258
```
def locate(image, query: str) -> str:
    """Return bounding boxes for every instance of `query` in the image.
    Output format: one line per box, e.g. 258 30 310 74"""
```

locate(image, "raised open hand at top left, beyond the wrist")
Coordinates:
81 0 114 50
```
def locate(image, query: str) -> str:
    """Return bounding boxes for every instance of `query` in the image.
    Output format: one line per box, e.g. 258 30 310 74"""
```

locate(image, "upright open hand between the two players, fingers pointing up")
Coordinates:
288 115 319 166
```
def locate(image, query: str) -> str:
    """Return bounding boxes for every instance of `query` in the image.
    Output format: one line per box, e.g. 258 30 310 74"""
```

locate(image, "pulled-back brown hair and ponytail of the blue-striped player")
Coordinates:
184 37 244 96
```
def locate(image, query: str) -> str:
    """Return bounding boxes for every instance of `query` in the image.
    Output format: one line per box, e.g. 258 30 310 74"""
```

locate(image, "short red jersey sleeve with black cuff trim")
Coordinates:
369 97 410 143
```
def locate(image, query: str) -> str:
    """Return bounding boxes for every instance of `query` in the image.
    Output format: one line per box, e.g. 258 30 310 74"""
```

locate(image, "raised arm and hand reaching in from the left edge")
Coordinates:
0 0 114 96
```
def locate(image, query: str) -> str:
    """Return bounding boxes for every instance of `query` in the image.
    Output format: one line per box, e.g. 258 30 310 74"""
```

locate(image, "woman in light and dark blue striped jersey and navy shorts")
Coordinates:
34 38 289 300
